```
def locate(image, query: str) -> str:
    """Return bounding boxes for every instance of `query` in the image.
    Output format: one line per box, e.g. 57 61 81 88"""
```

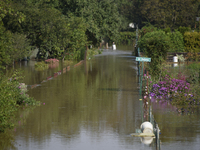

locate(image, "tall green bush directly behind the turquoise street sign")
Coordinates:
138 30 171 78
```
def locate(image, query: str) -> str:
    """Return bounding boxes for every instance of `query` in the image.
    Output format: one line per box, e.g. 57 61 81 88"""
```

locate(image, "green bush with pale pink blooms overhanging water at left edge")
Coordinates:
0 71 39 132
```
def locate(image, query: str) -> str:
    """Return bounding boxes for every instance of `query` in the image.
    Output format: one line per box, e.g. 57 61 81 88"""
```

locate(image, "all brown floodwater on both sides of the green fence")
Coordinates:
0 47 200 150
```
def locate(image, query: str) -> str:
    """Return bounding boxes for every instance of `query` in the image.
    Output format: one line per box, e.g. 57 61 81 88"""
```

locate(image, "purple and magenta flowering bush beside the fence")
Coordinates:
150 70 199 108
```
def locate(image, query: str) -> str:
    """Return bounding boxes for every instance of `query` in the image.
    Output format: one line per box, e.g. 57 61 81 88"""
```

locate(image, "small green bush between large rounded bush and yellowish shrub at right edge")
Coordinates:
167 30 184 52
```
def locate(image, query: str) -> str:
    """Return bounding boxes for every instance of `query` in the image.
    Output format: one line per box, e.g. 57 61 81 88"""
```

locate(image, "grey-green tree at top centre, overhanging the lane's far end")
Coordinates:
60 0 121 45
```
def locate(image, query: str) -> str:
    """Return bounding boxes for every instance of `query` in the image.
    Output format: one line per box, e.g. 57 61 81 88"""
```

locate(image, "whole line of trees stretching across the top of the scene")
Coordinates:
0 0 200 68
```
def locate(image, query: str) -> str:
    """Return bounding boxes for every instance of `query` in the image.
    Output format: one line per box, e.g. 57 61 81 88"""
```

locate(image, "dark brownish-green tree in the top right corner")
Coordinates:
141 0 199 29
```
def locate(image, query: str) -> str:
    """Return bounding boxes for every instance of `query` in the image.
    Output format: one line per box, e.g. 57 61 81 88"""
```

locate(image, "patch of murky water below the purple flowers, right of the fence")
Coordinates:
153 103 200 150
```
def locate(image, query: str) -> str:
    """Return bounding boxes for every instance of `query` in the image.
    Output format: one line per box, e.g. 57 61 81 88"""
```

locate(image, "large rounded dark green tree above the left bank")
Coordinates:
24 7 70 59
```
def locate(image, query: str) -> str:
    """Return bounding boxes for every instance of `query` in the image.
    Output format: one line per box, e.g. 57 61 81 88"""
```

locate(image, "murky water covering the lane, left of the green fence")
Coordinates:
1 51 154 150
